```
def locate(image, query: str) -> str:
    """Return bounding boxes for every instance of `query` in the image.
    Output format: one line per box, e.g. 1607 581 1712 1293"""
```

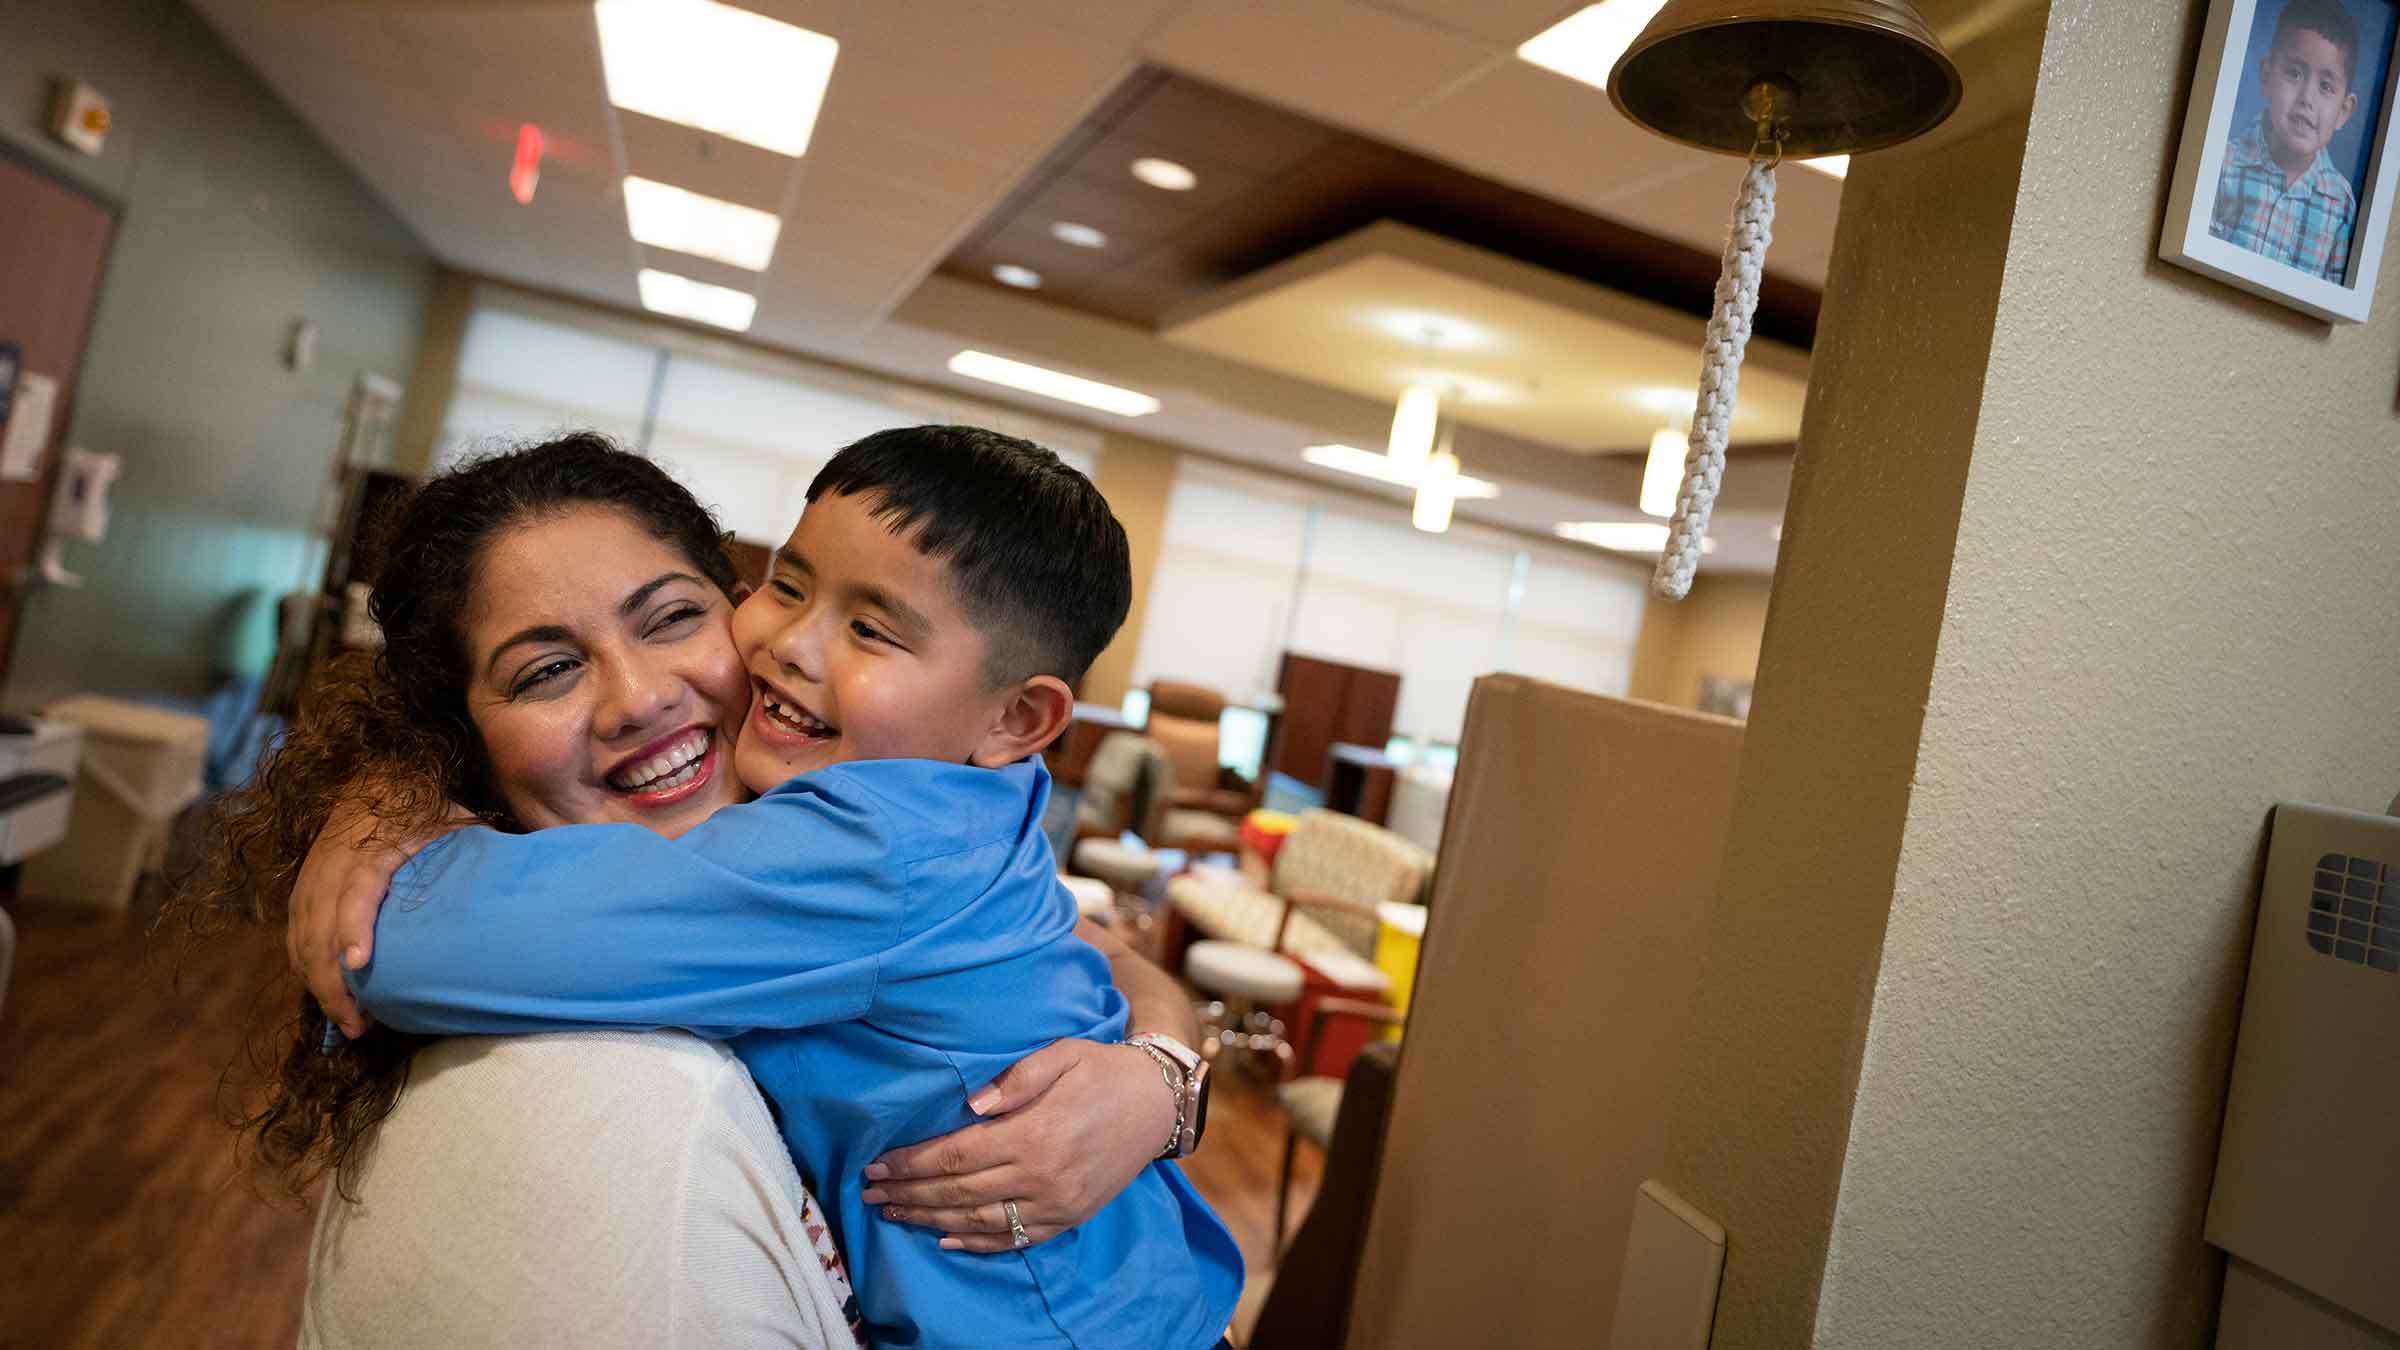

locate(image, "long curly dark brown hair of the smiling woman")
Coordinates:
170 432 734 1196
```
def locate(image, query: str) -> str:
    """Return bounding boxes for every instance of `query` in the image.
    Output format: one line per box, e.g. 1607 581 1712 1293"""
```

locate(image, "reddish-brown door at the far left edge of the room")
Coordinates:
0 142 118 680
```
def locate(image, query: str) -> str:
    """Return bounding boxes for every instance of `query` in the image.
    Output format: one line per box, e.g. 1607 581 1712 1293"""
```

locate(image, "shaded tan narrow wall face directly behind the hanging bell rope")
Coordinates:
1666 105 2030 1350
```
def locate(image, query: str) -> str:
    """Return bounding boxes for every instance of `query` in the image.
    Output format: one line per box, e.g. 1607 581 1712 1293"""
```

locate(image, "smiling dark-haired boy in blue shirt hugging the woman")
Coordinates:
353 428 1241 1350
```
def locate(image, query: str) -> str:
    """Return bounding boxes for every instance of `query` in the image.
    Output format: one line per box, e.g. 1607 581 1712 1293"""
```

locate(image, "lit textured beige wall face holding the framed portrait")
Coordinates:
1819 0 2400 1348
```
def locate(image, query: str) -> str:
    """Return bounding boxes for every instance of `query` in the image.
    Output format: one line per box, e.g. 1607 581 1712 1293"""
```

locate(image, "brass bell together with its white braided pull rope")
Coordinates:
1608 0 1963 601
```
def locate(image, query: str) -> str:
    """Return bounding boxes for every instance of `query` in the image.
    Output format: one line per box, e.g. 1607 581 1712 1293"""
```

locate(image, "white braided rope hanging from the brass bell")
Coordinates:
1651 154 1783 601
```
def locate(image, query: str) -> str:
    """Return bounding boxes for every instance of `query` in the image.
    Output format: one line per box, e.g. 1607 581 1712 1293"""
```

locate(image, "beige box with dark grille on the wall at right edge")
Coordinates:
2208 802 2400 1350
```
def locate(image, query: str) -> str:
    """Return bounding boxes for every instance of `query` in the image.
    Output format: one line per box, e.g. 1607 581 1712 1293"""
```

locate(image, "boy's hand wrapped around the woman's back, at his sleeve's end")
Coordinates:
283 800 475 1038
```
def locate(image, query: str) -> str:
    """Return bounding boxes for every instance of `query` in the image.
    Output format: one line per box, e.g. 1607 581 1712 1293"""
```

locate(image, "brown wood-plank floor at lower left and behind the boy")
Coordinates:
0 864 1318 1350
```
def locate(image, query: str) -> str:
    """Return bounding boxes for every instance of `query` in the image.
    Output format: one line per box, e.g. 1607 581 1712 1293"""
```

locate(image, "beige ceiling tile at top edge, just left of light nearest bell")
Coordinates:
1142 0 1493 130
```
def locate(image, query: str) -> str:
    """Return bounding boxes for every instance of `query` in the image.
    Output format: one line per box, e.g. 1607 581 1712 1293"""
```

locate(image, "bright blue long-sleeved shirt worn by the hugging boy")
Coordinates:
350 759 1241 1348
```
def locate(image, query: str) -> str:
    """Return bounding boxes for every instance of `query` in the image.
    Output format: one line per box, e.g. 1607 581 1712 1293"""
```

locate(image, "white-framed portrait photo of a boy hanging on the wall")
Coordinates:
2158 0 2400 324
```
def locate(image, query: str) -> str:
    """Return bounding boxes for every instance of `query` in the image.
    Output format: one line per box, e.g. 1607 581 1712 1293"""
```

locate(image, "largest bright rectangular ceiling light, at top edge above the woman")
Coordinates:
593 0 842 154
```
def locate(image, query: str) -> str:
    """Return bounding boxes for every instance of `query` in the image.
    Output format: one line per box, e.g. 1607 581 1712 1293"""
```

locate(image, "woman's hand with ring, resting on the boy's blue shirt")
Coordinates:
862 1040 1176 1252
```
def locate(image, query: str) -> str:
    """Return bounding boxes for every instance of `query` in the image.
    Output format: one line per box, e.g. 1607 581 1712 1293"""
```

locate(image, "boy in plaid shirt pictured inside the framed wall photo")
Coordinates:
2208 0 2359 281
